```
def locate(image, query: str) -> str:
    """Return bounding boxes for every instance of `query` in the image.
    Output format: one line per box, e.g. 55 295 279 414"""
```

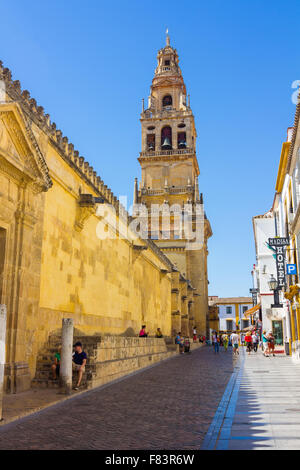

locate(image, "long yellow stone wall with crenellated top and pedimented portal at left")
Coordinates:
0 36 212 392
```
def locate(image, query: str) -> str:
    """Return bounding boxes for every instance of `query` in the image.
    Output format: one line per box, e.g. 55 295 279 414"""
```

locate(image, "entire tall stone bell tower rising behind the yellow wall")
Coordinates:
134 34 212 334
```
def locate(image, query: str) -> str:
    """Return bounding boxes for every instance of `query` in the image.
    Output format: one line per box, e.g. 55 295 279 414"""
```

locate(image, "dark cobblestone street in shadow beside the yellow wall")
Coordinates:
0 347 233 450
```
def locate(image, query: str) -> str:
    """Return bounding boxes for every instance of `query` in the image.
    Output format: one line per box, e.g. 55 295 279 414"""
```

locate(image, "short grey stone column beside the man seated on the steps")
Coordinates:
59 318 74 395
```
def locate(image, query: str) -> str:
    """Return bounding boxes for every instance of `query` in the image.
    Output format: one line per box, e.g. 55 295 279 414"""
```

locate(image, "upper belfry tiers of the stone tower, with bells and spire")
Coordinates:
139 29 199 198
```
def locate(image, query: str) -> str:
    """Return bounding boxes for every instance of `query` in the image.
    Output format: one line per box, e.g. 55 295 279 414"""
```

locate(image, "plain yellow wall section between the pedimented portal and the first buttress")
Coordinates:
31 152 171 376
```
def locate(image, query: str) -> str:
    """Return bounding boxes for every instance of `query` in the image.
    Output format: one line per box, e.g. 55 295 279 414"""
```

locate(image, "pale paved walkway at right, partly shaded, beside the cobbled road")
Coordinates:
203 348 300 450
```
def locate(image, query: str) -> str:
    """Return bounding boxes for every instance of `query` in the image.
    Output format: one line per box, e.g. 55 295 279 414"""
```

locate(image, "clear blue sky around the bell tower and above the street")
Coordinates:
0 0 300 296
